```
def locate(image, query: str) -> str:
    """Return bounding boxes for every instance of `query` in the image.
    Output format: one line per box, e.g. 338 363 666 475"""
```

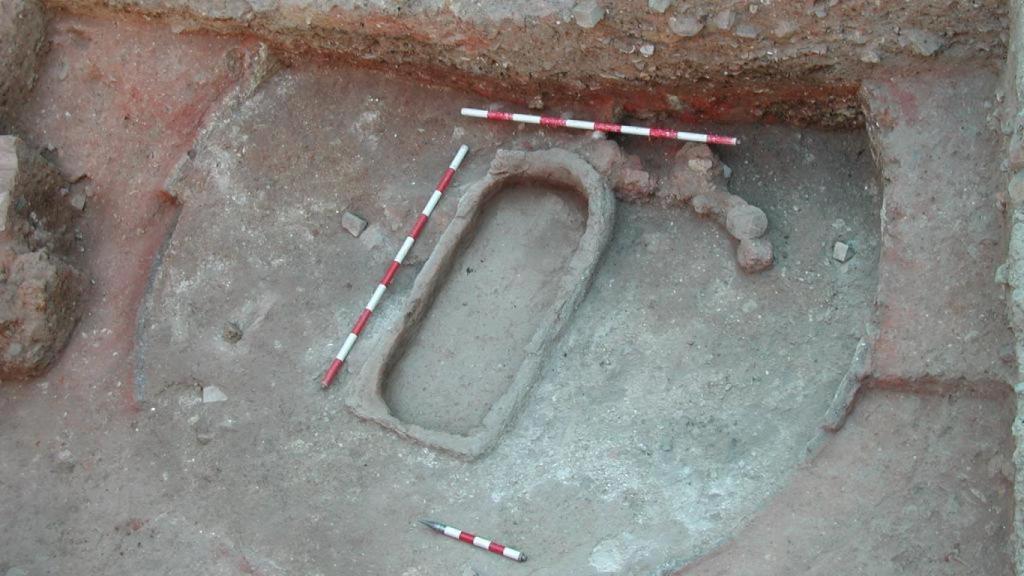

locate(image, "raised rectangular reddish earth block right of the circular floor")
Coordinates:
863 68 1014 389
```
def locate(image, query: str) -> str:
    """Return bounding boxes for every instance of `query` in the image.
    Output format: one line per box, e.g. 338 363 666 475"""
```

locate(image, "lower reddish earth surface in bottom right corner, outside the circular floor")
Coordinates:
677 390 1014 576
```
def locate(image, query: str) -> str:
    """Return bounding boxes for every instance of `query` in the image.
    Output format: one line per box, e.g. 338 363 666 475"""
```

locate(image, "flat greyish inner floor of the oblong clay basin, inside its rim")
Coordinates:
384 183 587 434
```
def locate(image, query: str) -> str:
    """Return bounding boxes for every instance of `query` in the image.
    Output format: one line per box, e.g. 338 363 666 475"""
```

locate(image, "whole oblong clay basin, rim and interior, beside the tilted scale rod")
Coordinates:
346 150 614 457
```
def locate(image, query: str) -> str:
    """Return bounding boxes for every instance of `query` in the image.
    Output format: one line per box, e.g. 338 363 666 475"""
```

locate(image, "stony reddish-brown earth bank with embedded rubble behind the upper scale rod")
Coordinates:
41 0 1008 127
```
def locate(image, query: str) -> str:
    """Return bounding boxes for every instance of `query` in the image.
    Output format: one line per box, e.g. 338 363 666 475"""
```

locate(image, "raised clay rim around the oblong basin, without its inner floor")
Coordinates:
345 149 615 458
